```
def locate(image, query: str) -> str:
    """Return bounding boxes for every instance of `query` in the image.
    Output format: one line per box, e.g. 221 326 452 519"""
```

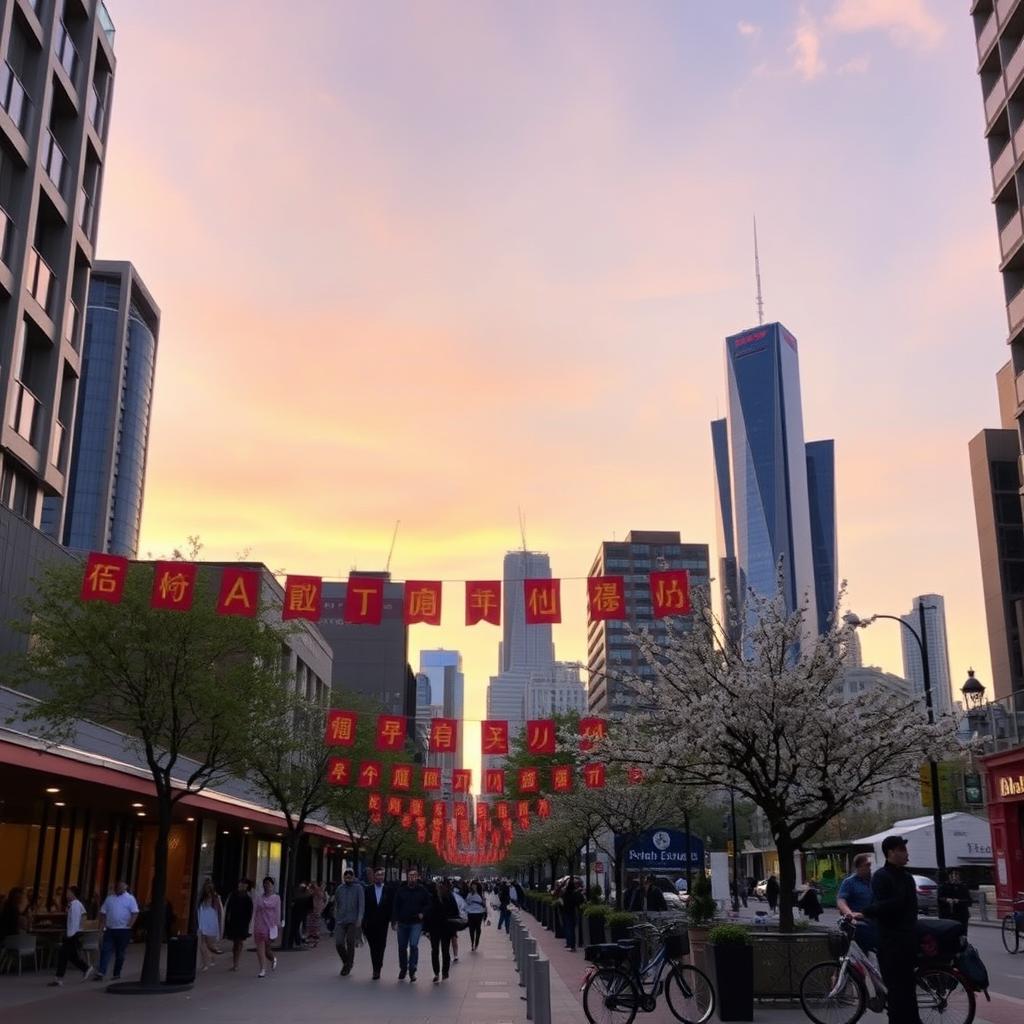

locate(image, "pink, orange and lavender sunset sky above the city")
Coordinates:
98 0 1008 737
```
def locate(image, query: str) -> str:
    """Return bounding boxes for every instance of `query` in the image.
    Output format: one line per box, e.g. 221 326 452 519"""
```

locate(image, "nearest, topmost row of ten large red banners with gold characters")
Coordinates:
75 552 692 626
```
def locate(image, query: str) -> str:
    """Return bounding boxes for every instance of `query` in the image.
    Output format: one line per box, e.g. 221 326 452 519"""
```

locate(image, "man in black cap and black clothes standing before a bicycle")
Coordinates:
863 836 921 1024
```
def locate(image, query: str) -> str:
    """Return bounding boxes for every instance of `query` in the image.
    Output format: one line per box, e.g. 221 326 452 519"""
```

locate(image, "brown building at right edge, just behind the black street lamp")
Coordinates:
968 362 1024 700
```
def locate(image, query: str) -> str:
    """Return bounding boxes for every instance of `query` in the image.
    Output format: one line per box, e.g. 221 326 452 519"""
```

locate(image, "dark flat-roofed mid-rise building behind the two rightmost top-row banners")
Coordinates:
587 529 710 716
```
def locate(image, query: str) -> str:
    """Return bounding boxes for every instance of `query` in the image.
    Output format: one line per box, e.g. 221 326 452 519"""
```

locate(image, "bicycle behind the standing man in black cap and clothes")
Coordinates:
800 919 976 1024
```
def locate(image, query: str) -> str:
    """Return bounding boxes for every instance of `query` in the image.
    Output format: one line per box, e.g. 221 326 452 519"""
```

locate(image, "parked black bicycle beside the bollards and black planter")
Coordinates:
580 923 715 1024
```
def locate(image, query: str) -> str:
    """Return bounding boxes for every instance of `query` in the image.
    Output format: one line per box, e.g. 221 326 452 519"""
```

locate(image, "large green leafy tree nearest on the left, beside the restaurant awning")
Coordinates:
11 564 285 985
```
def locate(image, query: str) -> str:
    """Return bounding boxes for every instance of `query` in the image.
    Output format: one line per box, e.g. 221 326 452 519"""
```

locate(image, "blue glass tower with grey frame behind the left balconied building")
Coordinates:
43 260 160 558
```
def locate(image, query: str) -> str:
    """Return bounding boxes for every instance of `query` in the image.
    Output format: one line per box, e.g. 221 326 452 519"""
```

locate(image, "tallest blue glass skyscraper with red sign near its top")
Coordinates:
712 323 838 632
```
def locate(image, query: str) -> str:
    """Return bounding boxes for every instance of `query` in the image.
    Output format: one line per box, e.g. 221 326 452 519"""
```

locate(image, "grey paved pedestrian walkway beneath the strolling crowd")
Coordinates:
0 927 552 1024
